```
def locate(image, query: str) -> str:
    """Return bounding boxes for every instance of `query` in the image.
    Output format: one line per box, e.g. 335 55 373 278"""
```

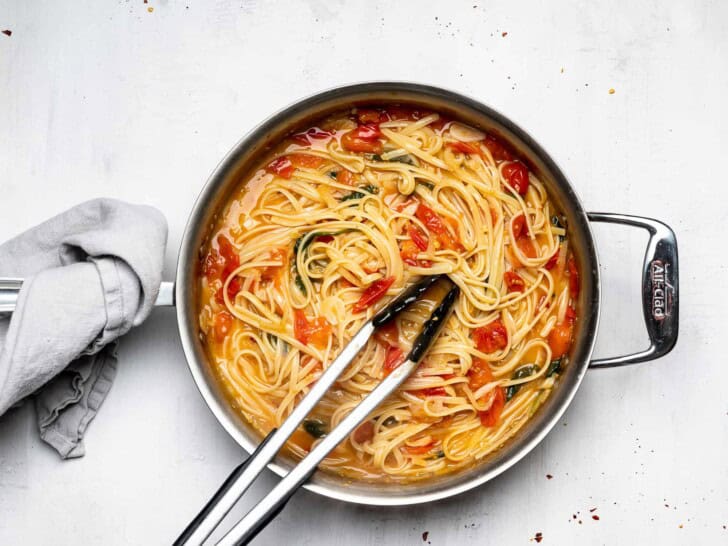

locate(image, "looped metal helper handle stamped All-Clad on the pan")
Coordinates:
587 212 680 368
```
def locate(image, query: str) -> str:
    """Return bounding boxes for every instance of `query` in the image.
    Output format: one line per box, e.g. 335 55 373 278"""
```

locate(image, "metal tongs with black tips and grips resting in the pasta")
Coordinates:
175 275 460 546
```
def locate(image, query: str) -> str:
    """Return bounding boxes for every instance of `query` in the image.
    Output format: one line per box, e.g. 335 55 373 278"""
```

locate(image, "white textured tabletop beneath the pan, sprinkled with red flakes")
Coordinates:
0 0 728 545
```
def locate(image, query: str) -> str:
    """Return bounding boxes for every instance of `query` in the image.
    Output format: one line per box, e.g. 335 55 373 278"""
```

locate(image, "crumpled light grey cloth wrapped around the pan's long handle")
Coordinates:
0 199 167 458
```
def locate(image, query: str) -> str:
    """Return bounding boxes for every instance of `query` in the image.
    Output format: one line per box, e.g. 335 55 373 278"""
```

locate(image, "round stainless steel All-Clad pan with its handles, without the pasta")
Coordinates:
0 82 679 505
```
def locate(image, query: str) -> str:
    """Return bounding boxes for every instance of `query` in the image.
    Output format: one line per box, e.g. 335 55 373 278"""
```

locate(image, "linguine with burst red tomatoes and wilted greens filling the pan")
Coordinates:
199 105 579 481
